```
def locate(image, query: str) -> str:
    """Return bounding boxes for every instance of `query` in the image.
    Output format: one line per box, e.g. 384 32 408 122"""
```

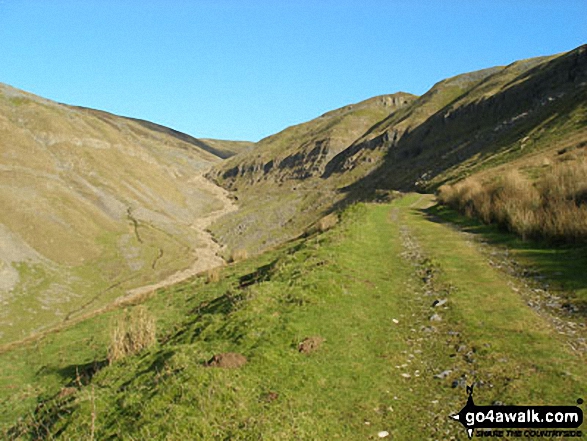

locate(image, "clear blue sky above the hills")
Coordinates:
0 0 587 140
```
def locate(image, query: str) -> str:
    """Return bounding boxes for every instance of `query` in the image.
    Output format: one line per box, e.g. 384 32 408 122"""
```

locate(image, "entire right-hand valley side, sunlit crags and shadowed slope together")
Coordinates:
211 46 587 251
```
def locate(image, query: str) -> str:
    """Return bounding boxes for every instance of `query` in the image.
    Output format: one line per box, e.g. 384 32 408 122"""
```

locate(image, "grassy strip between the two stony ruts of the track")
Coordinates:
406 196 587 405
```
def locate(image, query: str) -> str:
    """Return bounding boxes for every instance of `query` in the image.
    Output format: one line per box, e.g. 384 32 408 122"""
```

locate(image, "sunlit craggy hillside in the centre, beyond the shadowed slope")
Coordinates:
208 93 416 252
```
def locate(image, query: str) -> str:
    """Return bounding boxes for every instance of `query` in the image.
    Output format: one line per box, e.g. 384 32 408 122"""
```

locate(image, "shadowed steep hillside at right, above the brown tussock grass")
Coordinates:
329 46 587 189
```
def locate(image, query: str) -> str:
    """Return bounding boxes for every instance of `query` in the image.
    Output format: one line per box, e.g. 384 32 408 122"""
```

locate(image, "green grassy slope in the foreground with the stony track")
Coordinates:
0 195 587 440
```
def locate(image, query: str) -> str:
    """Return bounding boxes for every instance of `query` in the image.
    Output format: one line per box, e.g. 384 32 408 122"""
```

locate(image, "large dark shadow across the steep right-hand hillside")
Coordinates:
323 43 587 212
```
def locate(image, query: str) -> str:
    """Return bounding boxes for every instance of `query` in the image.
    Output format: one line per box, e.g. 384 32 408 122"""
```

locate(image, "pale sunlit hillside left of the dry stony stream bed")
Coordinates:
0 85 239 343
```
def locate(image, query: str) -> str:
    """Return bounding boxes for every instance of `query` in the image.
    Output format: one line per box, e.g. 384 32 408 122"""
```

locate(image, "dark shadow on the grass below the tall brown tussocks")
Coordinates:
414 201 587 317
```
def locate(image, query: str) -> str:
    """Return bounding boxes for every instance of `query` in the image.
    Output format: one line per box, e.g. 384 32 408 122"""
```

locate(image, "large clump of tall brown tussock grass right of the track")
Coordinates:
439 158 587 243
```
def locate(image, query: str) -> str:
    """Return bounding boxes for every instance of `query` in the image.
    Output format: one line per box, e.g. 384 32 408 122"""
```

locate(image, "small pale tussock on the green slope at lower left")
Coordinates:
108 305 157 363
